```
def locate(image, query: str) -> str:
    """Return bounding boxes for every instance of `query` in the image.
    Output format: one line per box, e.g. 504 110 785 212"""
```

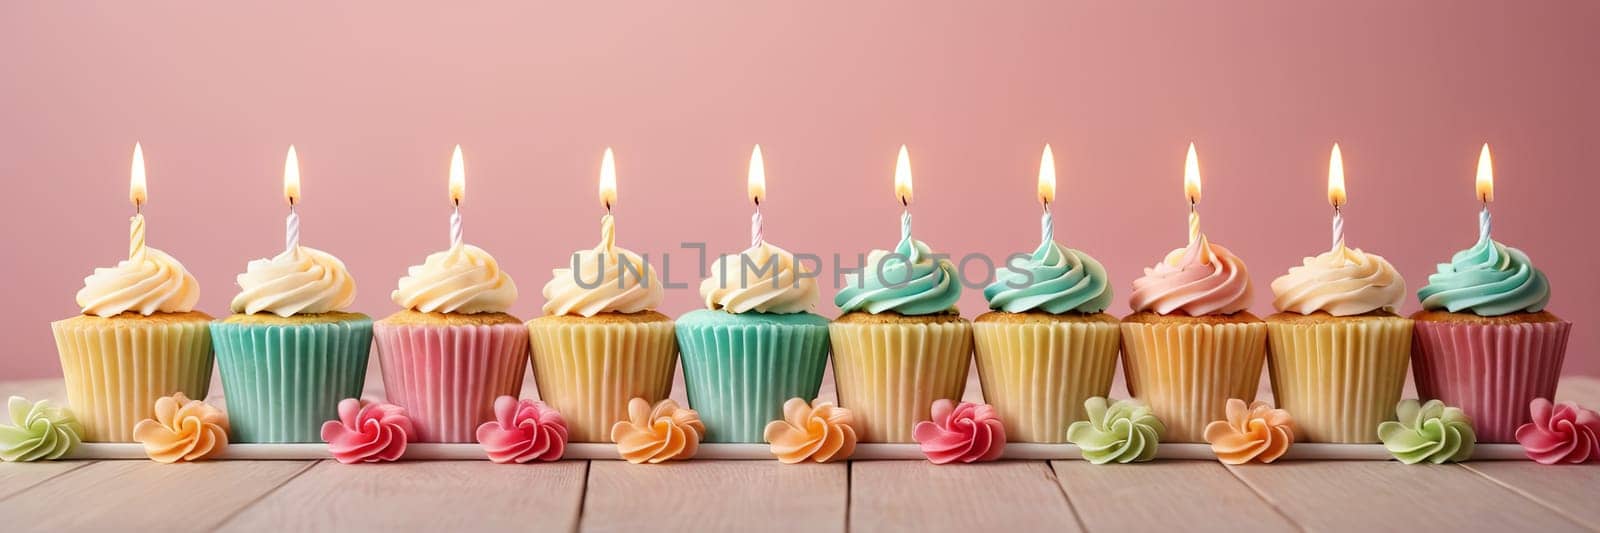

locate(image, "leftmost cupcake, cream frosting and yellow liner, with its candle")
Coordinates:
50 214 211 442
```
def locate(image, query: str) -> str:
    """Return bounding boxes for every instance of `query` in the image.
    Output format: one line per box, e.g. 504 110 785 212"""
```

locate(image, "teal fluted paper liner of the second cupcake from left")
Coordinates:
211 319 373 442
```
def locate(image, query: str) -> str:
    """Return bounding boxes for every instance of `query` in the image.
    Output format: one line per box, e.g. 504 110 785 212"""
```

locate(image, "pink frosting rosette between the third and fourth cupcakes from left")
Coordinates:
478 395 566 464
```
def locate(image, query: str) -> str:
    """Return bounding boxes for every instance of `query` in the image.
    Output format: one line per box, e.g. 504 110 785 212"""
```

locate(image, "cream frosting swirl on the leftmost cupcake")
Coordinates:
78 243 200 317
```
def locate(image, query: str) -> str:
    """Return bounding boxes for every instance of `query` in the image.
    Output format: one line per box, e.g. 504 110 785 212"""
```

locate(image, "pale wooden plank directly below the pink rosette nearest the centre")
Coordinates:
850 461 1082 531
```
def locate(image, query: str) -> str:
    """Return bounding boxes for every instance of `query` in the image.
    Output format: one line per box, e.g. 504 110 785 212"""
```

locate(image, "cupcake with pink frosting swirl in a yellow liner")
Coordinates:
1122 235 1267 442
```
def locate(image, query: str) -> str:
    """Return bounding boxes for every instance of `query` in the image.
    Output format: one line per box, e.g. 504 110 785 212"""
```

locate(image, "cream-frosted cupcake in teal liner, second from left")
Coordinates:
211 246 373 442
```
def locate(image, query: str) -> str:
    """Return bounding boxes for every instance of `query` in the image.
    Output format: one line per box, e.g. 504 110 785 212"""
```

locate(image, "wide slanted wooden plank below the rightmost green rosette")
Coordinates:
1229 461 1582 531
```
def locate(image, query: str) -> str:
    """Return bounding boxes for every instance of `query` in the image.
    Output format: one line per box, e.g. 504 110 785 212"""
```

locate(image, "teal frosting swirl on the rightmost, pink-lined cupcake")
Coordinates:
1416 235 1550 317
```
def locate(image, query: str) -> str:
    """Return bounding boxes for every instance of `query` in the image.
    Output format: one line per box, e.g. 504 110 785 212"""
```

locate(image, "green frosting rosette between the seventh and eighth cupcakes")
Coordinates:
1067 397 1166 464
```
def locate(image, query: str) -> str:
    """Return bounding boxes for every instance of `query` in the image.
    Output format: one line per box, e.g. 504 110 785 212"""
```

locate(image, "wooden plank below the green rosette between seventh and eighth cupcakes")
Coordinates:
1050 461 1296 533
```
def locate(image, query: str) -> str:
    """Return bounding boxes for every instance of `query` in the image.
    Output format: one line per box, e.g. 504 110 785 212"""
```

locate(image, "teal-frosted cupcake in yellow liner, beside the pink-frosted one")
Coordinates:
973 233 1122 443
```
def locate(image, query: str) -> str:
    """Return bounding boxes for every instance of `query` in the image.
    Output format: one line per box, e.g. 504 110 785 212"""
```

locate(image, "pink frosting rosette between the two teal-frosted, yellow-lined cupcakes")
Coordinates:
912 400 1005 464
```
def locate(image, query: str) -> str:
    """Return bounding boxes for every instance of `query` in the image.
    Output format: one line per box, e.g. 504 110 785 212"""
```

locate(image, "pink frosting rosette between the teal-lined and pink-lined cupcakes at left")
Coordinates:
322 399 416 464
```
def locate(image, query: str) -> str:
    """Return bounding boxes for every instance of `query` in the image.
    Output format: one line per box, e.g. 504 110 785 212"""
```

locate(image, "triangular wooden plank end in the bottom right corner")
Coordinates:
1464 461 1600 531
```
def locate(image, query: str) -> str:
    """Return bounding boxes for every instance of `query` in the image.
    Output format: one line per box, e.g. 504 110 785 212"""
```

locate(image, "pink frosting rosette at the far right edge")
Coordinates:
1517 399 1600 464
